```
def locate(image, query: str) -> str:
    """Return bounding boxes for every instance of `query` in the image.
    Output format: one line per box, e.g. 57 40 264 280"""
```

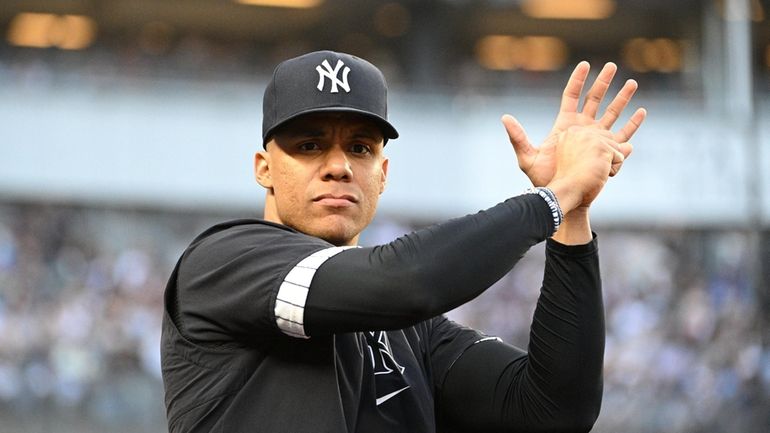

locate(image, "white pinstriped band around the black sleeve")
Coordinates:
275 247 355 338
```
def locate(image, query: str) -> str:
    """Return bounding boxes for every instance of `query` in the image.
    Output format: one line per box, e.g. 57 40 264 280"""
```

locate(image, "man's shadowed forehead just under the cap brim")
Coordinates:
275 112 383 139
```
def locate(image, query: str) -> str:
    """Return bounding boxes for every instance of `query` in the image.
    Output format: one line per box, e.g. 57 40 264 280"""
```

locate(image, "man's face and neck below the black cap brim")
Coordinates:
254 113 388 245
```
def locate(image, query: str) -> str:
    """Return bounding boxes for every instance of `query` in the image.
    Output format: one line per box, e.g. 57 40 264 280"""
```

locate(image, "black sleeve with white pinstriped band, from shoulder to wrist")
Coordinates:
176 194 554 345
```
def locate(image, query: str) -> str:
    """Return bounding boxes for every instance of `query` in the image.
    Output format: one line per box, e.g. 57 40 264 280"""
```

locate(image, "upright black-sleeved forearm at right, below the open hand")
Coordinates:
527 236 604 431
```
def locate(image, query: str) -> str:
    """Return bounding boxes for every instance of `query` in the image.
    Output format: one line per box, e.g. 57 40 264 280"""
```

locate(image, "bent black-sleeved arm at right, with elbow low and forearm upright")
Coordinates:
438 236 604 432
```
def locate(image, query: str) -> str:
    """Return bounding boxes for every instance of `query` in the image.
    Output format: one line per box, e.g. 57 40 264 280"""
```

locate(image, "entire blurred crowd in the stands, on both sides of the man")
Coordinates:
0 202 770 433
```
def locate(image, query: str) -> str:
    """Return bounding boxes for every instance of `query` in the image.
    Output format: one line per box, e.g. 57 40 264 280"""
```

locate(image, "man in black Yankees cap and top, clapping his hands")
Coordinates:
161 51 645 433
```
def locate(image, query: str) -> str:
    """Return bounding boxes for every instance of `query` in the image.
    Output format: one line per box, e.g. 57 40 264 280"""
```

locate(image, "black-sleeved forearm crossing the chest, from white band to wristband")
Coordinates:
305 194 553 335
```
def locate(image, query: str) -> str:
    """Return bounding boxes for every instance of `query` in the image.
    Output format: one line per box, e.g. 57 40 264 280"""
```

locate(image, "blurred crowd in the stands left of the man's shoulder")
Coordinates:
0 204 224 431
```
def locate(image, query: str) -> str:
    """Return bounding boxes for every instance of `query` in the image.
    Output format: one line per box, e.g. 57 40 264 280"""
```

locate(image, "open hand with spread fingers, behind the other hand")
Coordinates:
502 61 647 186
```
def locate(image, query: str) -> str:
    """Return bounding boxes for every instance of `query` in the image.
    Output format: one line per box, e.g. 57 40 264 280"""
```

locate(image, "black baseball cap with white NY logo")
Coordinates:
262 51 398 146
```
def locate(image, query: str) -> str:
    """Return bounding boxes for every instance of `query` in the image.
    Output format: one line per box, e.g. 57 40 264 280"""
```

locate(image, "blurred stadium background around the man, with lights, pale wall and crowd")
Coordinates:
0 0 770 433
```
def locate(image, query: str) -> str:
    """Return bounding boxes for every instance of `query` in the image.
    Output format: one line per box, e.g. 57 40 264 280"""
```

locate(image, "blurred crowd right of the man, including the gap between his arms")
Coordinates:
452 229 770 433
